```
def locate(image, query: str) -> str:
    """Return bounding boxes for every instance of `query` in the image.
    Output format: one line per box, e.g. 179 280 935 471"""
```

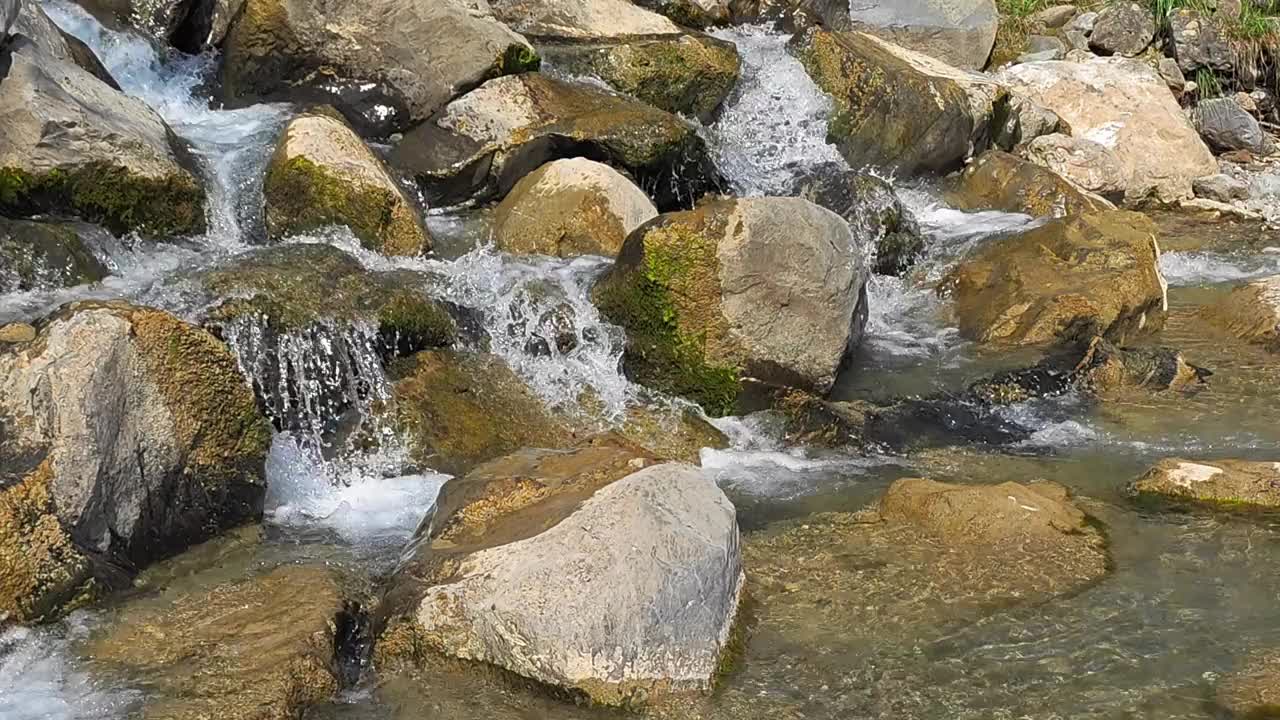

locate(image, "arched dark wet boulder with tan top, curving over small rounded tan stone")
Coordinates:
390 73 726 209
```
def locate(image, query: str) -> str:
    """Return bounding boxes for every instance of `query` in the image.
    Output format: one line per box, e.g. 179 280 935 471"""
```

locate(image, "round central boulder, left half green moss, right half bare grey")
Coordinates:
593 197 867 415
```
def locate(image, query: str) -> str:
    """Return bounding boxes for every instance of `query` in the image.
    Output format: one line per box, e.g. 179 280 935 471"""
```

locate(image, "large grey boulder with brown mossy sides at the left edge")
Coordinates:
0 302 270 621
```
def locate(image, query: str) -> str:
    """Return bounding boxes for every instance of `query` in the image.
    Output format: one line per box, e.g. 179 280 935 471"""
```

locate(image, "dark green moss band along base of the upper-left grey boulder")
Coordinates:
0 163 205 237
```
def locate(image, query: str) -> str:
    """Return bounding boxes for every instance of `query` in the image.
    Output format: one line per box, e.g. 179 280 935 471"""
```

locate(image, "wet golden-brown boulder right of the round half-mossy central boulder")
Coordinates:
940 210 1169 346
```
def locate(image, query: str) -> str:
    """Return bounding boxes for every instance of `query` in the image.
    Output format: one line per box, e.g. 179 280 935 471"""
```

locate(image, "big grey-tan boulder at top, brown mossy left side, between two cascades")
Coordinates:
221 0 539 137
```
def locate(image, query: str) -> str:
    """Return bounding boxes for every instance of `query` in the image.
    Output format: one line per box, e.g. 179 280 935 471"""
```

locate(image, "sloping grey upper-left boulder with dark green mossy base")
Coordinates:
0 38 205 237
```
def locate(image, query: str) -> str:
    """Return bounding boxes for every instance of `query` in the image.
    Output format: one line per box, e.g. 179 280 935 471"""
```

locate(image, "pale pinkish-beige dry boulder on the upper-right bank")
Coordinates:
998 57 1217 204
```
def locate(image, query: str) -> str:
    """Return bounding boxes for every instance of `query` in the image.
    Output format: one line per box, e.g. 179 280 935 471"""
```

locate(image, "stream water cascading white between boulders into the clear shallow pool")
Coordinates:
0 7 1280 720
